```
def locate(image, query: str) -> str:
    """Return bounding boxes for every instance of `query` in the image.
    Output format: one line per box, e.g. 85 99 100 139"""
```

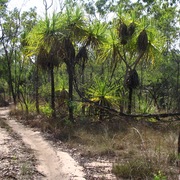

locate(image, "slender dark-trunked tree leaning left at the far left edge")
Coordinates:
0 9 20 104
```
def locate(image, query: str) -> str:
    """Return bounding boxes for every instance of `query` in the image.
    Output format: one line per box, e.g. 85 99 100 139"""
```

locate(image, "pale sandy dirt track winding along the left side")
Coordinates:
0 108 85 180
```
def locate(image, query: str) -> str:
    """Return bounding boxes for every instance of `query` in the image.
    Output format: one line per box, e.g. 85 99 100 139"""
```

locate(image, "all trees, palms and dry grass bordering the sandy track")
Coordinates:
0 0 180 180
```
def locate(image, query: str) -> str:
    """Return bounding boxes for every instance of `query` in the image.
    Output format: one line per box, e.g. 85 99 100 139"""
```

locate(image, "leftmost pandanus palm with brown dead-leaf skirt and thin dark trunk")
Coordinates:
27 13 61 116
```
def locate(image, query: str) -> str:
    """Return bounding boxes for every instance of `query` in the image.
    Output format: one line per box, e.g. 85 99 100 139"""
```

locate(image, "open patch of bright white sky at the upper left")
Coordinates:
8 0 59 16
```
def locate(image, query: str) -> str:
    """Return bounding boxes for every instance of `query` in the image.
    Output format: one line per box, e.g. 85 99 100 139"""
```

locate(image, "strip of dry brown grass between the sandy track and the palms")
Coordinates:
10 109 179 180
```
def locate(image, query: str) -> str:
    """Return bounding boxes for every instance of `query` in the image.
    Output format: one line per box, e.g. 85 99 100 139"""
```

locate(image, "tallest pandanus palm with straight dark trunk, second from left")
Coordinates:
58 6 85 121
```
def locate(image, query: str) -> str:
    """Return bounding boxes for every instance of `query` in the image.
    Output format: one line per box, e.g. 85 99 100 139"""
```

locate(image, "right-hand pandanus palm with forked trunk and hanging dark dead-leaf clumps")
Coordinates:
97 9 164 113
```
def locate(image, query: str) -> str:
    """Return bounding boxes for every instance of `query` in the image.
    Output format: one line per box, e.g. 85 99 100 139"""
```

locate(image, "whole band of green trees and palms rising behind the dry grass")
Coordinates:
1 0 180 121
